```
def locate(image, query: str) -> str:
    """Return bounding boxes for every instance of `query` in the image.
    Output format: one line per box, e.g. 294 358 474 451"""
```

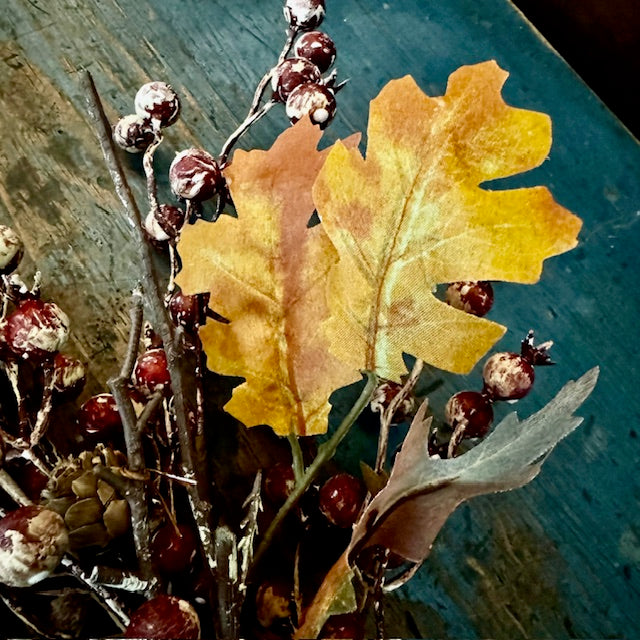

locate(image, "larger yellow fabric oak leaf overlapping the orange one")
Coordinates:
314 62 581 380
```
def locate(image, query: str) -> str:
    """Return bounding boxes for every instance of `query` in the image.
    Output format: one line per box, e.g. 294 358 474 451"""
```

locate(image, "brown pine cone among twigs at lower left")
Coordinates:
41 445 130 550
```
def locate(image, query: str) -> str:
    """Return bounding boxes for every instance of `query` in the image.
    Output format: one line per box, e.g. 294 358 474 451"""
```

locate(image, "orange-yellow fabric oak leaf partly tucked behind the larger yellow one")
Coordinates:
177 120 360 435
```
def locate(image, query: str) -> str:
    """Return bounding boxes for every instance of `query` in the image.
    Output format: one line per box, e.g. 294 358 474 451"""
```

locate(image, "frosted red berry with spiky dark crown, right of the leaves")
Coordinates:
482 352 535 400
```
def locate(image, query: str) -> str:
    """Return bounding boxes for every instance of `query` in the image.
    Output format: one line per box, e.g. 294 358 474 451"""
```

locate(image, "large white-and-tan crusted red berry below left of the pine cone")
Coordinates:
0 505 69 587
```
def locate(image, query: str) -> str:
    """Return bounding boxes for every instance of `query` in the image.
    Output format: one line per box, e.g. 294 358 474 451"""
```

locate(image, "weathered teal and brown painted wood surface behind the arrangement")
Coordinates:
0 0 640 638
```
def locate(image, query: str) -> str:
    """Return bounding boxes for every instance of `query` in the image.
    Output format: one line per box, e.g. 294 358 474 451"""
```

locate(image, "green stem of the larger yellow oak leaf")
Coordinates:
252 371 378 569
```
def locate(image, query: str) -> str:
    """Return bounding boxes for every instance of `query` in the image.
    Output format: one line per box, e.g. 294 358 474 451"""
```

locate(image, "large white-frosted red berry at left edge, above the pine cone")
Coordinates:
4 298 69 360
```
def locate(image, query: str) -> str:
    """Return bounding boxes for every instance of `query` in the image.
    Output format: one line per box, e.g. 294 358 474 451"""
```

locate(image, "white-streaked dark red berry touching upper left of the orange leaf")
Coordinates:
169 149 222 202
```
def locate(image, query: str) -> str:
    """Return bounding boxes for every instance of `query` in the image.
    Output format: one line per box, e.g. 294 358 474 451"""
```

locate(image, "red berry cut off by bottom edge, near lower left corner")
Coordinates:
124 595 200 640
